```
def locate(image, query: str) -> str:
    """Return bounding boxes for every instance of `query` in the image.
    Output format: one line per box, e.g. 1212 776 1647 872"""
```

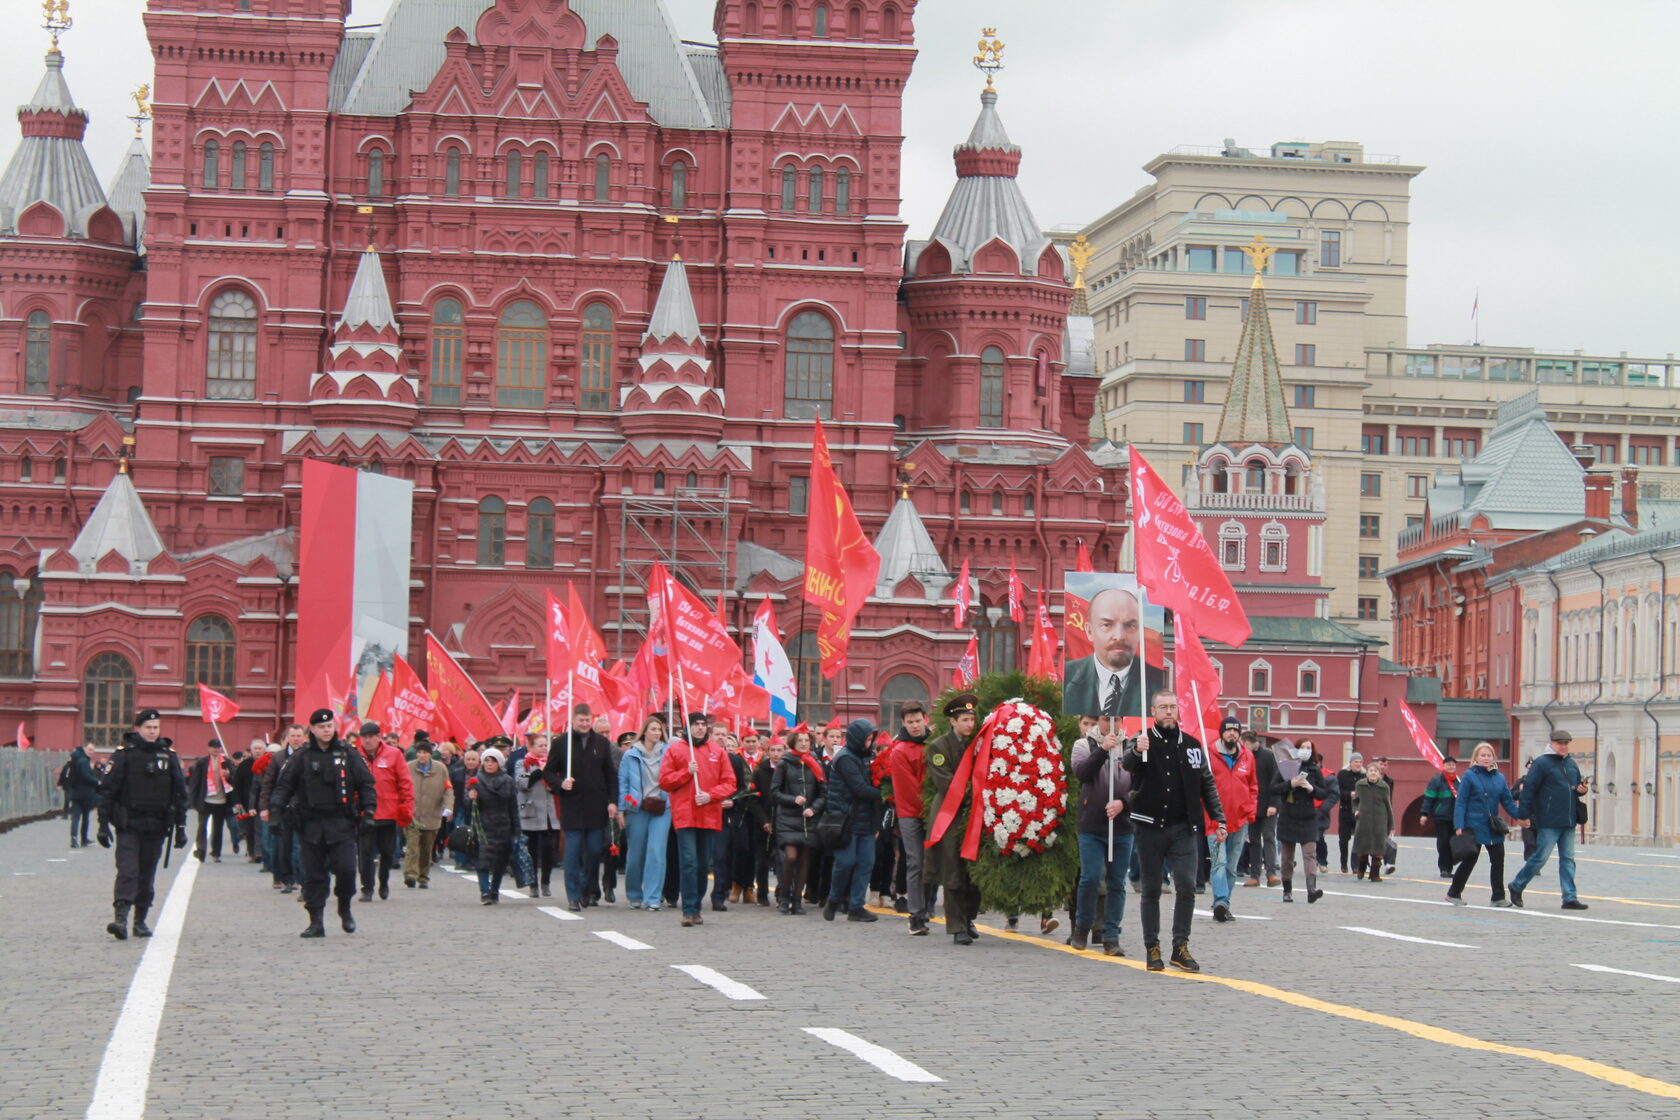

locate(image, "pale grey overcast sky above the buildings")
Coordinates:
0 0 1680 358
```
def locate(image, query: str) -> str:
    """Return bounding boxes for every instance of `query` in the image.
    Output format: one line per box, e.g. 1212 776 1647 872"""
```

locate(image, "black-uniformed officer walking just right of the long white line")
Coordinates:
269 709 376 937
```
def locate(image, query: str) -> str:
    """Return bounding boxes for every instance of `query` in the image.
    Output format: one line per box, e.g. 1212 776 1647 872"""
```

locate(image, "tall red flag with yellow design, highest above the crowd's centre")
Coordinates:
805 420 880 677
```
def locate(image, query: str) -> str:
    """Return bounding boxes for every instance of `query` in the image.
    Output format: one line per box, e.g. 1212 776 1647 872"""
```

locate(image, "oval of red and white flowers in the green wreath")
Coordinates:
981 699 1067 856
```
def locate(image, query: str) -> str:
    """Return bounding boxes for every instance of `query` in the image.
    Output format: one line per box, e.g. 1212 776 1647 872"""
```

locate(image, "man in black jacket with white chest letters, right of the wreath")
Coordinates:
1121 688 1225 972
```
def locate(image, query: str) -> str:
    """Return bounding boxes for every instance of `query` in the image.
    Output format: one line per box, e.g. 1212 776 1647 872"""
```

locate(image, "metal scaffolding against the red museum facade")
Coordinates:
612 485 731 658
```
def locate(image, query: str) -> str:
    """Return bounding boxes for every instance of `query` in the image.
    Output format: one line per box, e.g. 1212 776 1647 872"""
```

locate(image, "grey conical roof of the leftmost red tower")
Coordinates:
0 50 106 237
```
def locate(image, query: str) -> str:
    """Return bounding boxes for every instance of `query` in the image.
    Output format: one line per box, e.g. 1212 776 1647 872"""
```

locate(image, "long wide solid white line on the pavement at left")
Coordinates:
87 860 202 1120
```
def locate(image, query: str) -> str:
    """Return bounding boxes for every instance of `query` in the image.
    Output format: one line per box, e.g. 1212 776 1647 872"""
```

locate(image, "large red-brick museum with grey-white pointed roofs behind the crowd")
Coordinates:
0 0 1126 749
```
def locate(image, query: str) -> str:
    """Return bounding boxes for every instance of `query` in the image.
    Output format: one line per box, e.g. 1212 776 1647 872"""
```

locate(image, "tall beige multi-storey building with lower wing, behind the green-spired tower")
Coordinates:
1082 141 1680 640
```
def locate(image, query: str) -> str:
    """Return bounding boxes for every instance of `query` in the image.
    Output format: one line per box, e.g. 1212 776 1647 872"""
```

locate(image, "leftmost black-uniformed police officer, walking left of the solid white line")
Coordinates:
99 709 186 940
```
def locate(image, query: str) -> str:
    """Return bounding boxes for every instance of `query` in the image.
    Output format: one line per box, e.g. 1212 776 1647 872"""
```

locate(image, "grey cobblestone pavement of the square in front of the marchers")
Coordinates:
0 821 1680 1120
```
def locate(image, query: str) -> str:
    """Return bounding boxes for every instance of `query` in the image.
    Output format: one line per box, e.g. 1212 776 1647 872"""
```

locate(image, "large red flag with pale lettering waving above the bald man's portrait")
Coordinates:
1131 445 1253 646
